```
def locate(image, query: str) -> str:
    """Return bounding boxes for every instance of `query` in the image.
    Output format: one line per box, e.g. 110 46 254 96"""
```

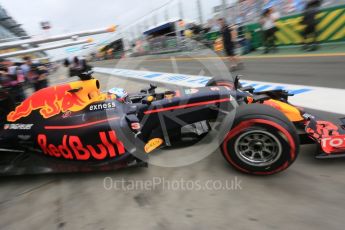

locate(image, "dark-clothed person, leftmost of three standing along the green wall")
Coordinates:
218 18 243 70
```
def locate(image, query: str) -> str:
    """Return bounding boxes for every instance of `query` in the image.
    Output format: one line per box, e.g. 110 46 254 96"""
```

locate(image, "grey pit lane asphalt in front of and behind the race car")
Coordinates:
0 58 345 230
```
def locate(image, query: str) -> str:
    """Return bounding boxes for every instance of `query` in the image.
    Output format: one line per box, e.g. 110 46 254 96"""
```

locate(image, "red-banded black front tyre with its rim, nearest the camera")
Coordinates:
220 104 299 175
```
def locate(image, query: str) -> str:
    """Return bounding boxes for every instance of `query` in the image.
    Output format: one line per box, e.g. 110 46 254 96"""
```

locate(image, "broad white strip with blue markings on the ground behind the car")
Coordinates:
94 67 345 114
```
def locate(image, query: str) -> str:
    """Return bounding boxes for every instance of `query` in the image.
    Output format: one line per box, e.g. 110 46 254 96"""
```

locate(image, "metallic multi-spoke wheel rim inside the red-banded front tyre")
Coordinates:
235 130 282 167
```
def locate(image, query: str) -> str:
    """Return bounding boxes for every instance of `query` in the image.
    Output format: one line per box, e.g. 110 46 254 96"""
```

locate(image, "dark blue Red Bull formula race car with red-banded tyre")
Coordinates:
0 71 345 175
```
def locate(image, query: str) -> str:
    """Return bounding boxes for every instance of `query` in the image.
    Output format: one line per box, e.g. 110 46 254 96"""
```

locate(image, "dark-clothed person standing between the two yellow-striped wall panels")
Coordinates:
302 0 321 51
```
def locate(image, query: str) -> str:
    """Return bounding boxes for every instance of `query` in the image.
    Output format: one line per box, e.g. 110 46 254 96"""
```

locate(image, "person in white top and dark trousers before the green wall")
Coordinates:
260 8 279 54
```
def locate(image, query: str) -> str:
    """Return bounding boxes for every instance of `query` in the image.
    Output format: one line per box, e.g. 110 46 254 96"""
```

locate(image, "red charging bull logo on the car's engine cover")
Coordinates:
7 83 86 122
